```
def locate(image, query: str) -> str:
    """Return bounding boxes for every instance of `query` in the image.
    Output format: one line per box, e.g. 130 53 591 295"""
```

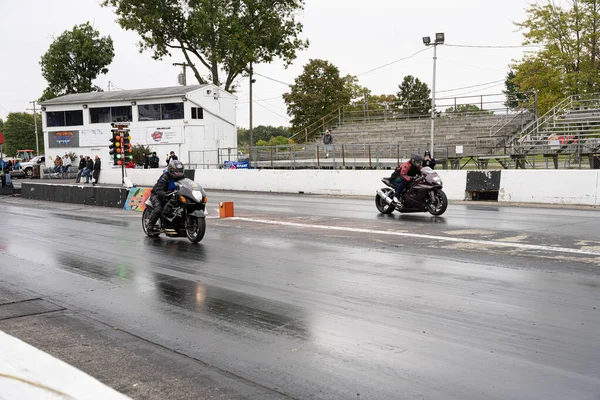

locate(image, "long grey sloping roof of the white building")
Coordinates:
41 84 208 106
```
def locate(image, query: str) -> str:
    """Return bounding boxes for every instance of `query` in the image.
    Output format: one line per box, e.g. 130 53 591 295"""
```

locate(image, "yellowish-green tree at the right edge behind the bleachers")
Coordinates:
511 0 600 113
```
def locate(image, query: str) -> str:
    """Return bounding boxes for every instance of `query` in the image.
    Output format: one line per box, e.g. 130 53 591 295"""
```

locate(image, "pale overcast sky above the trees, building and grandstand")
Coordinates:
0 0 527 127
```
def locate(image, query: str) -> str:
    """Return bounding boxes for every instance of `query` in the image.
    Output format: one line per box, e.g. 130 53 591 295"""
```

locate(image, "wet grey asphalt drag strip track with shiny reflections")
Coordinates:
0 192 600 400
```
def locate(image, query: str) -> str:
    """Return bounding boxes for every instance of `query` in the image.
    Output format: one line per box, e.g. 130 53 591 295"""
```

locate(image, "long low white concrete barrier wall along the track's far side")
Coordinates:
100 169 600 205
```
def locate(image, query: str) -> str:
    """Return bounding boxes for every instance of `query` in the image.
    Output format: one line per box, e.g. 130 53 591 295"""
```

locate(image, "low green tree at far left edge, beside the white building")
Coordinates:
2 112 44 156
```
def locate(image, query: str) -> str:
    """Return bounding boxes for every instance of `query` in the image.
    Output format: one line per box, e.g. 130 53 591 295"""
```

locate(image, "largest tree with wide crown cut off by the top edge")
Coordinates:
102 0 308 91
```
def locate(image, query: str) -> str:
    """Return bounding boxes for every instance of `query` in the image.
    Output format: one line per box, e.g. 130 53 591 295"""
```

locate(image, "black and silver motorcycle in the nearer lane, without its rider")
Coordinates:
142 178 208 243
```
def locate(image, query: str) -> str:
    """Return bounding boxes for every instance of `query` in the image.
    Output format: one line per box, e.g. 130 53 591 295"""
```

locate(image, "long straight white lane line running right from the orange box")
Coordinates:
230 217 600 257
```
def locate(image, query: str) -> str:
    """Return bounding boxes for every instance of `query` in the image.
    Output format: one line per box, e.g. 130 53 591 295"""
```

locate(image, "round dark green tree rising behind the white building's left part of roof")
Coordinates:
40 22 114 100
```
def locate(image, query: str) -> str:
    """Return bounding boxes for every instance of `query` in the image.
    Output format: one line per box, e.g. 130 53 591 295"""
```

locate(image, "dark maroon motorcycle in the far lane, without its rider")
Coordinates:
375 167 448 216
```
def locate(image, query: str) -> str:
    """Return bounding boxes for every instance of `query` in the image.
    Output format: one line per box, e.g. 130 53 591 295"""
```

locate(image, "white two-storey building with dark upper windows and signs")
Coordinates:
41 84 237 168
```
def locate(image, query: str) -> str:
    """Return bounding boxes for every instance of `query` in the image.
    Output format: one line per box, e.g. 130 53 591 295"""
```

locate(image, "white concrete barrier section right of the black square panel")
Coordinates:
498 170 600 205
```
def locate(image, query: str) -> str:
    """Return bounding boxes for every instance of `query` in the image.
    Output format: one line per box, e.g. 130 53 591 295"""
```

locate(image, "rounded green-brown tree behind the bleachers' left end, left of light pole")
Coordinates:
283 60 361 129
